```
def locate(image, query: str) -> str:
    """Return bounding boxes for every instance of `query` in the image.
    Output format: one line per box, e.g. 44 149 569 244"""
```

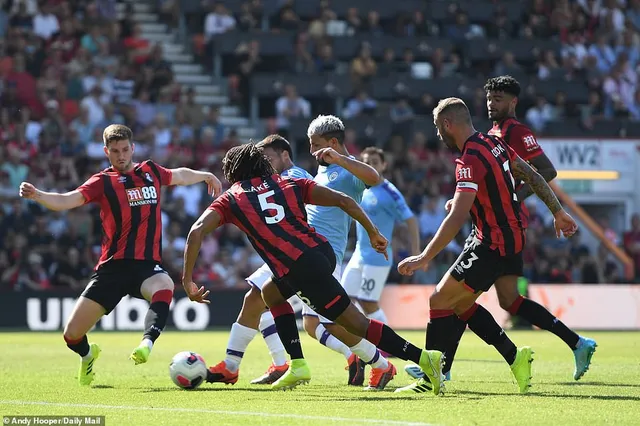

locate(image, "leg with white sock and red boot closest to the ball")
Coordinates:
207 286 264 385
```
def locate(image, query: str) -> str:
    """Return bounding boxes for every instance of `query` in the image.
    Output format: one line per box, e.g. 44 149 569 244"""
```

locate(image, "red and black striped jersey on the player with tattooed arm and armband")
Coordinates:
456 132 527 256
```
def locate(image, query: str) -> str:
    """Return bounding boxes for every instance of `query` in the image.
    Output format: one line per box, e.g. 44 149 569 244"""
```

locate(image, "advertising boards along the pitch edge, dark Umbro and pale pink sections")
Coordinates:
0 284 640 331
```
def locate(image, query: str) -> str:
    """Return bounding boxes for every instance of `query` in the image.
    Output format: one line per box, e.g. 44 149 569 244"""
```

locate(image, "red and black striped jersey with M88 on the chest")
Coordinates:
78 160 172 268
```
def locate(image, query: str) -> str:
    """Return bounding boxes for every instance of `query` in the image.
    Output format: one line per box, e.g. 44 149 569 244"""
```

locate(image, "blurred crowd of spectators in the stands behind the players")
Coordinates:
0 0 640 291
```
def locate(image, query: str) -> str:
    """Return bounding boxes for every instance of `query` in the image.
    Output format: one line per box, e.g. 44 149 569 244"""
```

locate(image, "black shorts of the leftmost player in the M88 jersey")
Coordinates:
82 259 166 314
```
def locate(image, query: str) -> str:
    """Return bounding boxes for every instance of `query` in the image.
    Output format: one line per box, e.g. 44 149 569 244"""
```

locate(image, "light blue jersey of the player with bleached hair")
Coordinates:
306 161 365 265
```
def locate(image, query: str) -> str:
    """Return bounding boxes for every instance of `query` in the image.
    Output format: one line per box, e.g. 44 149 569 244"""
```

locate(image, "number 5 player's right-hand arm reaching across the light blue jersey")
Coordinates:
305 182 389 259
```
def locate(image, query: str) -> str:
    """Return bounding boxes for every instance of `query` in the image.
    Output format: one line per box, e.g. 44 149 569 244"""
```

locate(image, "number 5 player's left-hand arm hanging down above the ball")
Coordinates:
182 208 222 303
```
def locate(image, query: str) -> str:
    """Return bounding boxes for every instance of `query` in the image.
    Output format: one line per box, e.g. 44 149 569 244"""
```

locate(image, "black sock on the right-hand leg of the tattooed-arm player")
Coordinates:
460 304 518 365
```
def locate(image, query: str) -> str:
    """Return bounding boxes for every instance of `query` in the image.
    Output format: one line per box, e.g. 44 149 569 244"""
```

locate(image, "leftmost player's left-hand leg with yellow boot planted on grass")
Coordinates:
64 296 106 386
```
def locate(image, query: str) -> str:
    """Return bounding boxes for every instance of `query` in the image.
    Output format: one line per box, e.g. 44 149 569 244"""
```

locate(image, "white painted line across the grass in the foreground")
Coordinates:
0 400 435 426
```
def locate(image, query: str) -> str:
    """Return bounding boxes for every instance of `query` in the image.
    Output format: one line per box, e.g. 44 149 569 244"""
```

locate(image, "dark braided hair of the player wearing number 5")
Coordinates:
222 143 276 184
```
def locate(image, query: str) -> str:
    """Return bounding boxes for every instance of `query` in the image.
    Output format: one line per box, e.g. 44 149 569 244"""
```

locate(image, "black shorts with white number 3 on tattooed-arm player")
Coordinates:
449 238 524 293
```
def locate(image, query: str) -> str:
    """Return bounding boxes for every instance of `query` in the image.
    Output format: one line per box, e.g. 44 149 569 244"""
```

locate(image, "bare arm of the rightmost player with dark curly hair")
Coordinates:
511 155 578 237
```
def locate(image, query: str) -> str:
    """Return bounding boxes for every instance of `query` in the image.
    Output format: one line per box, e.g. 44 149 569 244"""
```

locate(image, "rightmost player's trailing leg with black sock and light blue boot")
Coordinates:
495 276 598 380
